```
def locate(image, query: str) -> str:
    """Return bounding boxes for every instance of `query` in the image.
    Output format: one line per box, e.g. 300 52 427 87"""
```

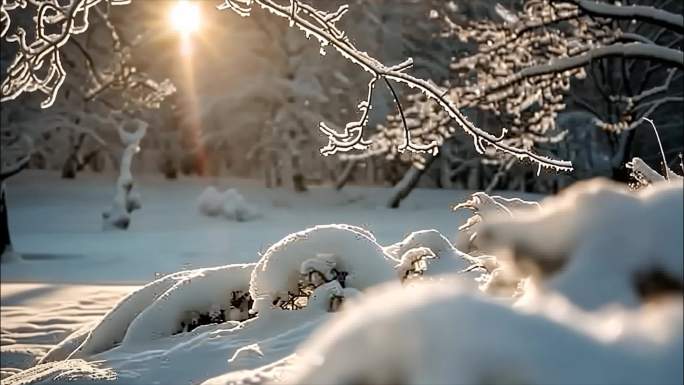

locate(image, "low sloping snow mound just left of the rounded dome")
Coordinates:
40 264 255 363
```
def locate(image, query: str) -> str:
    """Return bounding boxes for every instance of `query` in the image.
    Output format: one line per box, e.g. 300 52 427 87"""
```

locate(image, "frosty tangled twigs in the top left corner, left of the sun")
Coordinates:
0 0 175 108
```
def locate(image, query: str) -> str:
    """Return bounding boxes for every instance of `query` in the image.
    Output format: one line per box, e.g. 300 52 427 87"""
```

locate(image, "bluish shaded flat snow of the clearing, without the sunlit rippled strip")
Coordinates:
2 171 480 284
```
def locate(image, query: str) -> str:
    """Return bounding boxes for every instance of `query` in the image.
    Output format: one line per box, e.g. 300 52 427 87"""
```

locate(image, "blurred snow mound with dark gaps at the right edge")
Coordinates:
479 180 684 308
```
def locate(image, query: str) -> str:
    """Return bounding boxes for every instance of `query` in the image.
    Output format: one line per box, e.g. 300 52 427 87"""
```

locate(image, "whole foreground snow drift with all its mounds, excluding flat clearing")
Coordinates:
6 180 684 385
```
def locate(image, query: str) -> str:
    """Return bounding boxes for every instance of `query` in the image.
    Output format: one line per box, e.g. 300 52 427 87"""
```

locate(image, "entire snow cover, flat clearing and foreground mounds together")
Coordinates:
1 173 684 385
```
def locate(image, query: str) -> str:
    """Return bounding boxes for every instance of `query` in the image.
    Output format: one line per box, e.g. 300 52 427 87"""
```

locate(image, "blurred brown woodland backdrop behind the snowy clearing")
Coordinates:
1 0 683 205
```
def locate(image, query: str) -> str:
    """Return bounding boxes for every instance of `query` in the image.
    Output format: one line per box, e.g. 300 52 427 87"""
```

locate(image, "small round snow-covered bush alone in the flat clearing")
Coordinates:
197 186 261 222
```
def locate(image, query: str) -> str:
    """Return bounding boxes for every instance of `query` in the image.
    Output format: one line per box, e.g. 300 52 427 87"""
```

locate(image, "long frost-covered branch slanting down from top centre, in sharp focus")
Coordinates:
219 0 572 170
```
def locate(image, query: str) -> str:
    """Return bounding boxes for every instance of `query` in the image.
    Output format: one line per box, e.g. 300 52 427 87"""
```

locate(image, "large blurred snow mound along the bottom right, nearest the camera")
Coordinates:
290 280 683 384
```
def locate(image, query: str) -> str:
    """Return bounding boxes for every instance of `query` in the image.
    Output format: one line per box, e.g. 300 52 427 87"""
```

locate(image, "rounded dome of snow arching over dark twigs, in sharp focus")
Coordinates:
250 225 396 313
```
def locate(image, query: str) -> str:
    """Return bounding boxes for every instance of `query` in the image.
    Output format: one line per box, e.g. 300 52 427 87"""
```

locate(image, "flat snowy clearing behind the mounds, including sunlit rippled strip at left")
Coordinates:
0 171 484 377
